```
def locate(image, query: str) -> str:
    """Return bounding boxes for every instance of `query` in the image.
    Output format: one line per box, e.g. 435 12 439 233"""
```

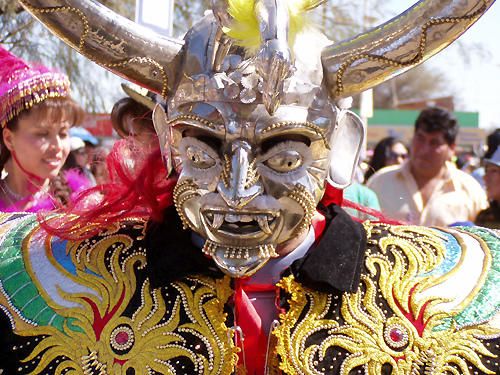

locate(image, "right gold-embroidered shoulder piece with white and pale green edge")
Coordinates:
274 222 500 375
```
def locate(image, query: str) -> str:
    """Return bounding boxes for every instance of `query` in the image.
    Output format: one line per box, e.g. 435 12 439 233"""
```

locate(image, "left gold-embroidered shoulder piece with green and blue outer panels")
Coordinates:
0 216 237 375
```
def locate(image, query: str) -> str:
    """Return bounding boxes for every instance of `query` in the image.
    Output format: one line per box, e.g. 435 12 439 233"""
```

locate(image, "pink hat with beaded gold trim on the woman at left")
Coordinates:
0 46 69 128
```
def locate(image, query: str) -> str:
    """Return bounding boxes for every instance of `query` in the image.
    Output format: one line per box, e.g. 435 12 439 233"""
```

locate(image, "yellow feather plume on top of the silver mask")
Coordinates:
224 0 325 50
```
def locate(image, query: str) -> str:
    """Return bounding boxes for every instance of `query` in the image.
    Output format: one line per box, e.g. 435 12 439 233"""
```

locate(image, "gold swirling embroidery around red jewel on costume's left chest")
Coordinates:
16 223 238 374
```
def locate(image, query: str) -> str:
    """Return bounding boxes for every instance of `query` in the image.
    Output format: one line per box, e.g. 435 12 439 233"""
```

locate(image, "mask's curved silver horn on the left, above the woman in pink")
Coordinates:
20 0 183 97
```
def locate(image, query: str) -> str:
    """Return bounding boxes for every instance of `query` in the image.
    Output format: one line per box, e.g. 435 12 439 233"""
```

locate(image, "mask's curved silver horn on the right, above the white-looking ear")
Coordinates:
322 0 495 99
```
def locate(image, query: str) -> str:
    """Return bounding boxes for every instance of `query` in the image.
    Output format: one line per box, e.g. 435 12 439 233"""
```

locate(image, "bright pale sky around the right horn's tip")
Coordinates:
387 0 500 129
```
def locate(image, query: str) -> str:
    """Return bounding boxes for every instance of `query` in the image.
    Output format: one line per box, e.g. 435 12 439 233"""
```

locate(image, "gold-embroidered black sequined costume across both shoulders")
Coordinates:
0 208 500 374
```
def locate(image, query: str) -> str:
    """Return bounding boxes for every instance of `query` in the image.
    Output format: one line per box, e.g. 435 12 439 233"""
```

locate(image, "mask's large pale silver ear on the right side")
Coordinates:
327 110 366 189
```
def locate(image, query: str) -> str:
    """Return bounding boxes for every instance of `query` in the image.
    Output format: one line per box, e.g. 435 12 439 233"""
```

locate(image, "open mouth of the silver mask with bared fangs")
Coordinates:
203 209 279 236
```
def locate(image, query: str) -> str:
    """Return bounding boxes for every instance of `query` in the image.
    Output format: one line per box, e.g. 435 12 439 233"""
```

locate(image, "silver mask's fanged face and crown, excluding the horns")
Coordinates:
154 12 363 277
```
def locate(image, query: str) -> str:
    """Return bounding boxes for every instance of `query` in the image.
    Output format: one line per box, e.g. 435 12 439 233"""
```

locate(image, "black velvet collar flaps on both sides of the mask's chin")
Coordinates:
146 205 366 293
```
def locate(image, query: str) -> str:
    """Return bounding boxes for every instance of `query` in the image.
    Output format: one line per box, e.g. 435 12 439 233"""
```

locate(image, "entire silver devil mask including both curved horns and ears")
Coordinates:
20 0 494 277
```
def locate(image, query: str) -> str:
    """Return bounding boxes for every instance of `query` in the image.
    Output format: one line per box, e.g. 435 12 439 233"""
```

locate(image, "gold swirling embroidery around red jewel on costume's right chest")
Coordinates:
274 223 498 375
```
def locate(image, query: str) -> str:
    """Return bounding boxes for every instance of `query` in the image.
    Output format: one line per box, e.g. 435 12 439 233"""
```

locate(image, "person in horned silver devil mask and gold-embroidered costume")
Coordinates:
0 0 500 375
